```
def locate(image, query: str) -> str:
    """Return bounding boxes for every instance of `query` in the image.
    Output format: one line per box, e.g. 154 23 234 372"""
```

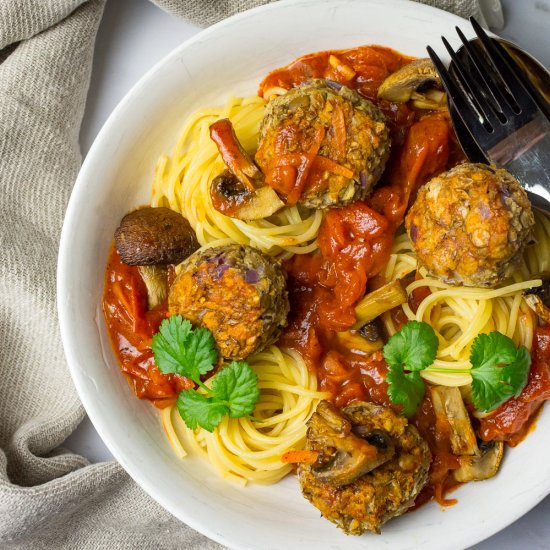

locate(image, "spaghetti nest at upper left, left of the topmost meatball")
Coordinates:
151 96 323 258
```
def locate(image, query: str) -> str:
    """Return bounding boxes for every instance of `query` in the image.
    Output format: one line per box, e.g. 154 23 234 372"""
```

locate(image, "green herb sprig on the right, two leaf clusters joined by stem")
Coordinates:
384 321 531 416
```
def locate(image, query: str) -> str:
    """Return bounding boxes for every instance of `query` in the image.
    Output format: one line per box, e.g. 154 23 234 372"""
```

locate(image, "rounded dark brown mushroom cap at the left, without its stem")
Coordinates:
115 207 200 265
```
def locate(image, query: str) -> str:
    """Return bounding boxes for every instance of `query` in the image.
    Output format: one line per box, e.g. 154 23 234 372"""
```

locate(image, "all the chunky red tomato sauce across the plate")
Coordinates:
103 46 550 505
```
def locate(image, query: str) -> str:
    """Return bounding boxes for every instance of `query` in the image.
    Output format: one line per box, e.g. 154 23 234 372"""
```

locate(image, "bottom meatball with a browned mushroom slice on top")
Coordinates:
298 401 431 535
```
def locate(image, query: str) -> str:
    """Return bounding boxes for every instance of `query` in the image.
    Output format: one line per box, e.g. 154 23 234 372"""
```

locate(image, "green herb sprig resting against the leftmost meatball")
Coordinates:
152 315 260 432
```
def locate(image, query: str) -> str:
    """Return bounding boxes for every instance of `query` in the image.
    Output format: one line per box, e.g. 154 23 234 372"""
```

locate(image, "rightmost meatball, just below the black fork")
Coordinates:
405 164 535 287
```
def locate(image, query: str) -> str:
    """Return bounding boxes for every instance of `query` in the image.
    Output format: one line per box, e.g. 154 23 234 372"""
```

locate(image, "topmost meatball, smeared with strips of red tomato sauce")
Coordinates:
255 80 390 208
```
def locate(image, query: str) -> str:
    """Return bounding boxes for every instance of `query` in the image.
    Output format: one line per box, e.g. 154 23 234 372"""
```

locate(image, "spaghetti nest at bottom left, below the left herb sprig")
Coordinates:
162 346 327 485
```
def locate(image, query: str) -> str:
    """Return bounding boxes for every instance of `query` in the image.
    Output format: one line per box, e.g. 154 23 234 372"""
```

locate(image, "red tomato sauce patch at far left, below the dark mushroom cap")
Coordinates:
103 246 194 408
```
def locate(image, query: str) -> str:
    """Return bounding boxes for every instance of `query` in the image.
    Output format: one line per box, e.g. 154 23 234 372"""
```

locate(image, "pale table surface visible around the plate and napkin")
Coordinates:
66 0 550 550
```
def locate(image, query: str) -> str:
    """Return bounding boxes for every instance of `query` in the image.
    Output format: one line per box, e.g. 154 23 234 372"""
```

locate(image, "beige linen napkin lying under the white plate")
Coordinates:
0 0 502 549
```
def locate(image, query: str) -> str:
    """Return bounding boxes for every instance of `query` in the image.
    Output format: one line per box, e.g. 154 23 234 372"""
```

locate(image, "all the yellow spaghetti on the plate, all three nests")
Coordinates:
152 90 550 484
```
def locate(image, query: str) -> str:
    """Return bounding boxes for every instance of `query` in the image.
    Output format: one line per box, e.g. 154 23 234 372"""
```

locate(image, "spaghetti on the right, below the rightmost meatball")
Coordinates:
383 211 550 386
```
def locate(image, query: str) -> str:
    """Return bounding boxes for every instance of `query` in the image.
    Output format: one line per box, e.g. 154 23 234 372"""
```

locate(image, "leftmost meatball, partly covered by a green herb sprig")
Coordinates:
168 245 289 360
